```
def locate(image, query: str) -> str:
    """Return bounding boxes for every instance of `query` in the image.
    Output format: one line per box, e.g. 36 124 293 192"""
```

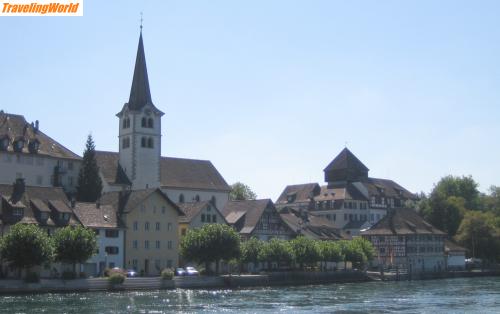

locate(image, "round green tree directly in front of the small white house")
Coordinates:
53 226 97 272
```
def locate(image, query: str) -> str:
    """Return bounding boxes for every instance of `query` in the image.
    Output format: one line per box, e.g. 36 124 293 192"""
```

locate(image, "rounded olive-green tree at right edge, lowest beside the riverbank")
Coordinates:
455 211 500 260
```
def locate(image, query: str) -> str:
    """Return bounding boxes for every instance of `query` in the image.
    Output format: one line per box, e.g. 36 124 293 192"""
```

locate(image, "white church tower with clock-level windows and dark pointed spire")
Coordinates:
116 27 164 190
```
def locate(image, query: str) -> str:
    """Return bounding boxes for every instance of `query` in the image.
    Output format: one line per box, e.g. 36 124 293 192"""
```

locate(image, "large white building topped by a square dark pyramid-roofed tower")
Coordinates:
276 148 416 235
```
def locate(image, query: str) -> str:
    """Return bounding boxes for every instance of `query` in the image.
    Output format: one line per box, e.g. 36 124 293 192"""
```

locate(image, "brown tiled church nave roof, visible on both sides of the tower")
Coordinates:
96 151 230 191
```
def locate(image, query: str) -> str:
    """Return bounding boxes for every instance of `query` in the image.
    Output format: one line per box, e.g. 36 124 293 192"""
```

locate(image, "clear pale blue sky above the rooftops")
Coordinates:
0 0 500 199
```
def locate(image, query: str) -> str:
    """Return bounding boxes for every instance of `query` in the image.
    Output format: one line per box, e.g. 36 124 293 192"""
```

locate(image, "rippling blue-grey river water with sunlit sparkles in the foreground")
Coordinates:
0 277 500 313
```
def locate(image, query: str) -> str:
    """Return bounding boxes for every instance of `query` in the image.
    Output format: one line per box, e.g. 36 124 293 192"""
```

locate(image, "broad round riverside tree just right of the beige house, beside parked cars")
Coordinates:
181 224 241 274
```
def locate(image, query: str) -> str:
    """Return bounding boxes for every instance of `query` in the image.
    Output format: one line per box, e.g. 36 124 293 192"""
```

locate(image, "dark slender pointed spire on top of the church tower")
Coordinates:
128 29 153 110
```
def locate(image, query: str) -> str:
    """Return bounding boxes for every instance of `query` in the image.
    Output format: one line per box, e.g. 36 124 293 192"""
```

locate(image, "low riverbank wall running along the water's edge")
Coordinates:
0 271 500 294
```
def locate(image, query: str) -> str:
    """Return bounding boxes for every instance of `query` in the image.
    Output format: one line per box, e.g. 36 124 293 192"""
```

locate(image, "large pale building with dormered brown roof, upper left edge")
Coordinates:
0 111 81 192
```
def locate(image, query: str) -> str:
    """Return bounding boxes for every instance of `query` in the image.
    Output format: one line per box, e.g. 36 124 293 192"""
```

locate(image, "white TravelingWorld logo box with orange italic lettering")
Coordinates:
0 0 83 16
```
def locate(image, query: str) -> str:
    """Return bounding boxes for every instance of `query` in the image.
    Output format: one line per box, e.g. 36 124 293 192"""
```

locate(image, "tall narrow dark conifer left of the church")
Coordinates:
76 134 102 202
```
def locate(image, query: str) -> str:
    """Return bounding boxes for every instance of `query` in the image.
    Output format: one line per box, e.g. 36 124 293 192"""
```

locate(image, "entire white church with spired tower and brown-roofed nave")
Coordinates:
96 31 230 208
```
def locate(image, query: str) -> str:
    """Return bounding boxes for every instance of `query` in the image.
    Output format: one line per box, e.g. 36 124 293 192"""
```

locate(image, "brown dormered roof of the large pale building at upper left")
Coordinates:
0 110 81 160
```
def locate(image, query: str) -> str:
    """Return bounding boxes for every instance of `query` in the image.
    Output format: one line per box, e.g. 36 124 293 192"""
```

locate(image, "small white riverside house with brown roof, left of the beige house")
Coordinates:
73 202 125 276
